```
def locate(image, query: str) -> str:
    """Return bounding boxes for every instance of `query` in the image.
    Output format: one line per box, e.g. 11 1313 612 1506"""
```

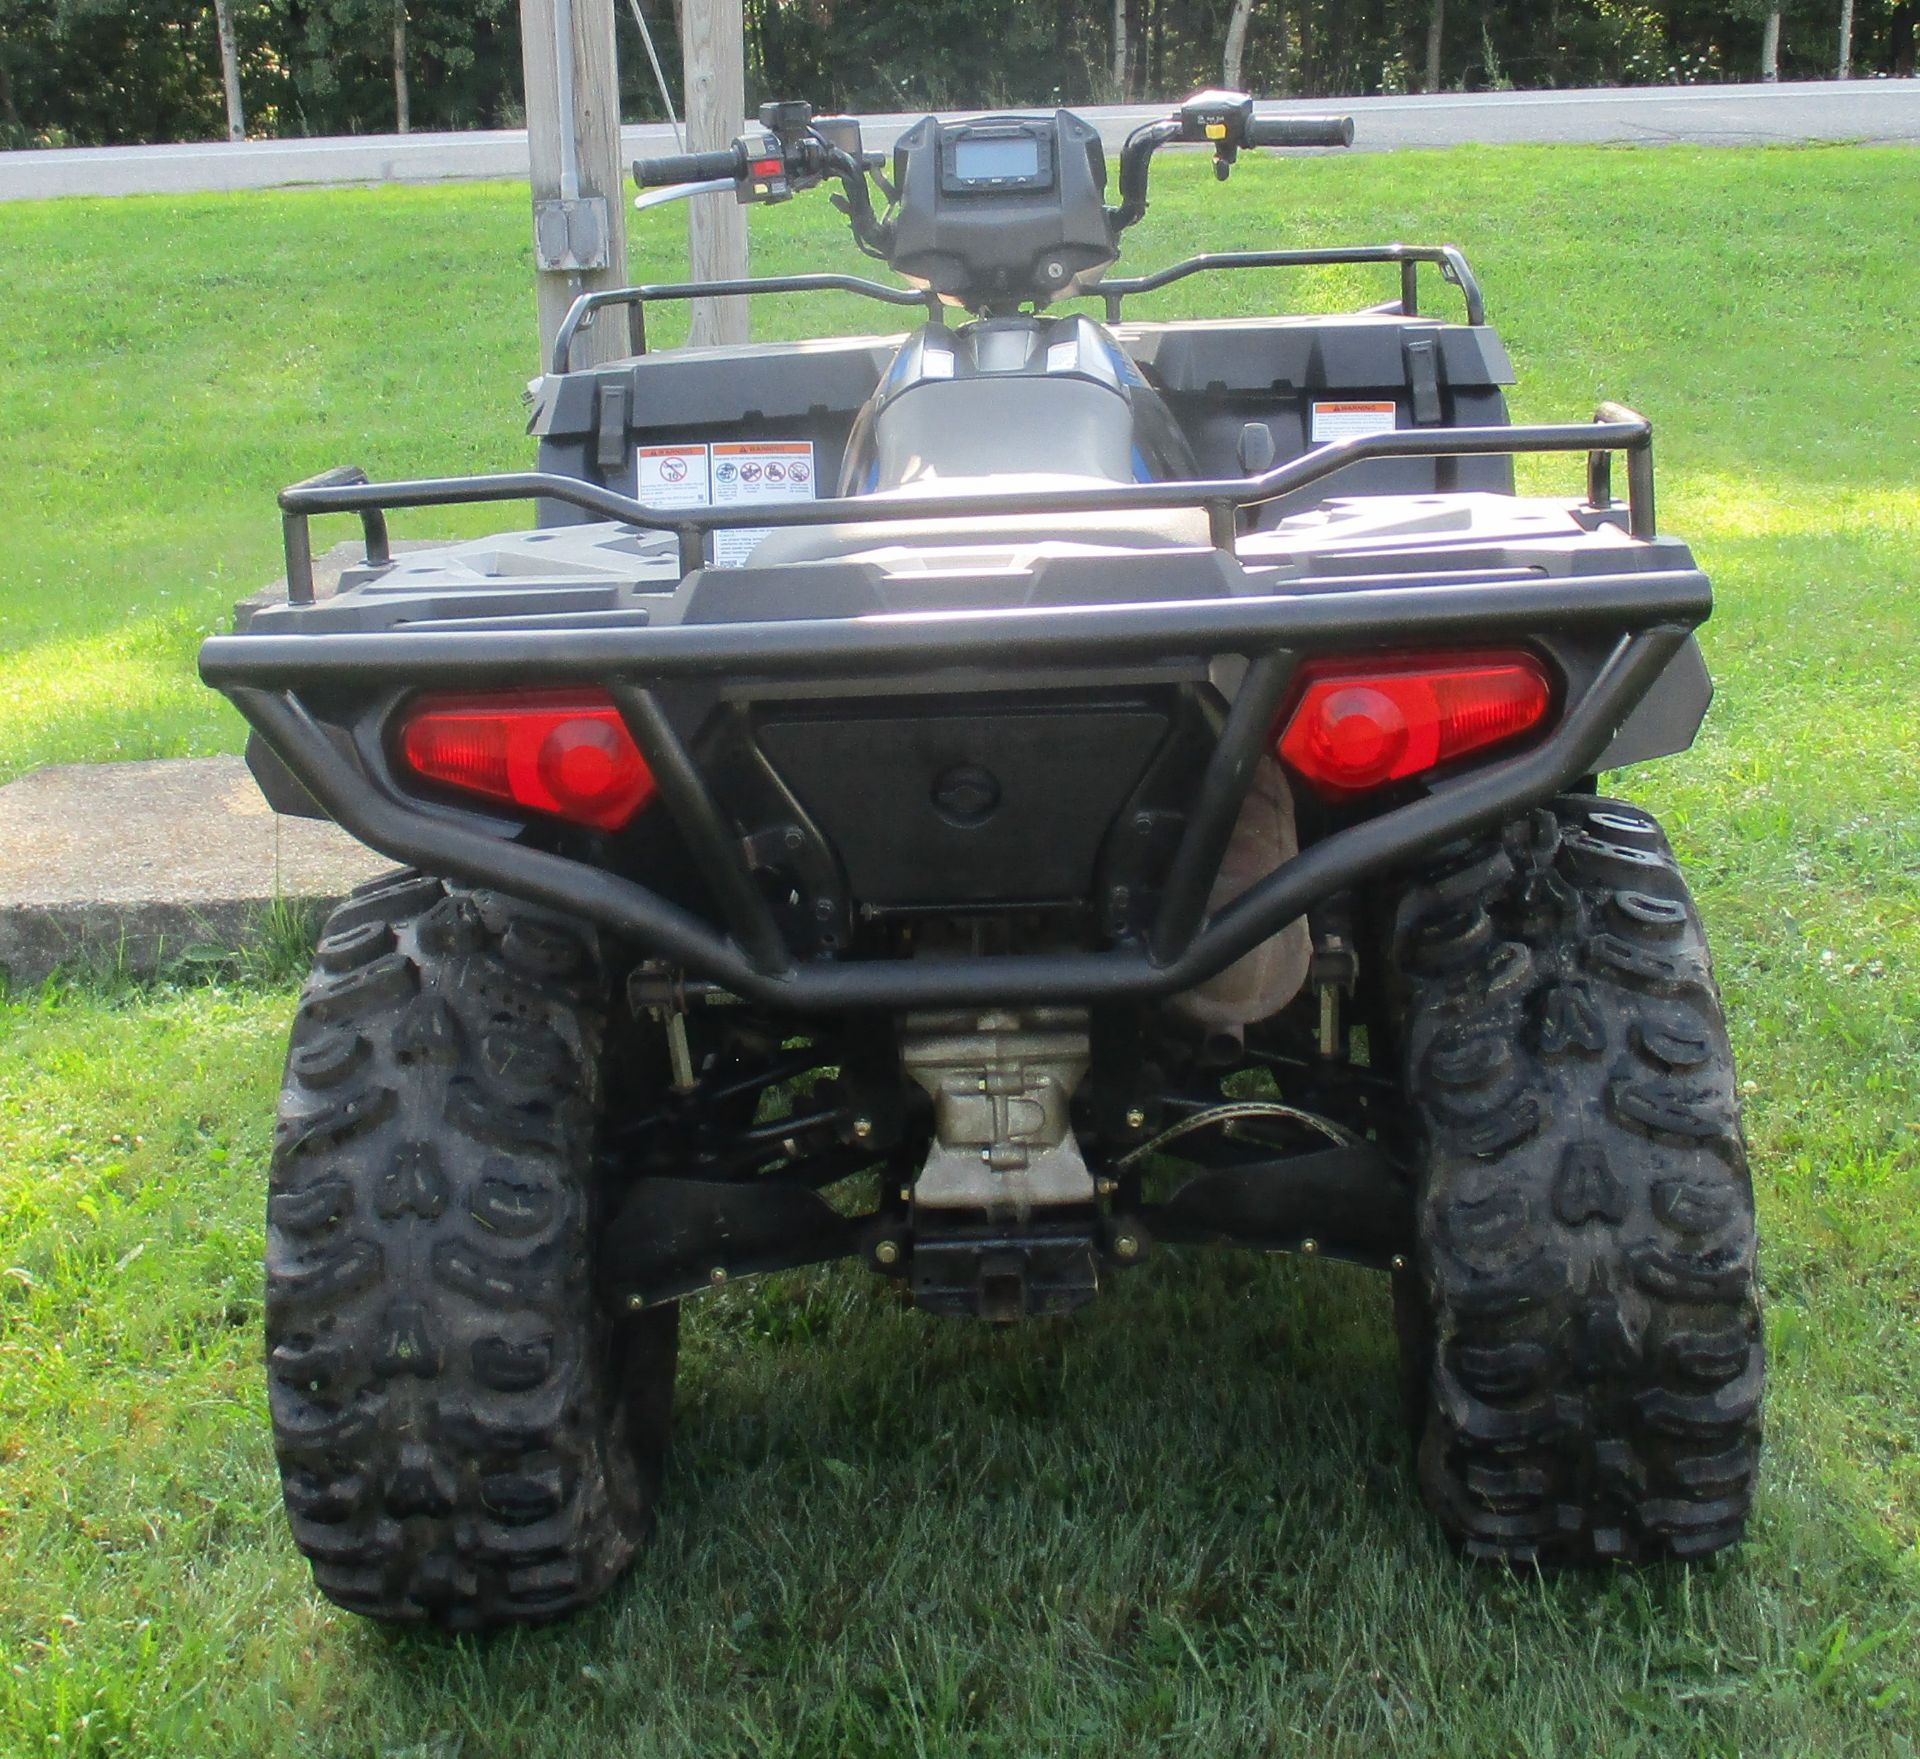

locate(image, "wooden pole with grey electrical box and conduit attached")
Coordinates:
520 0 628 371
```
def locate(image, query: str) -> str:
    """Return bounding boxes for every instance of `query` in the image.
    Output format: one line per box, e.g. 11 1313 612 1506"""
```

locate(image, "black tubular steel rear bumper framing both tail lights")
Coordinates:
200 568 1711 1014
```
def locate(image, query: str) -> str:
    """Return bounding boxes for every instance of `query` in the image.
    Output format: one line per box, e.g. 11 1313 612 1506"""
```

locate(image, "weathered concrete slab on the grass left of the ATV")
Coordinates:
0 757 392 985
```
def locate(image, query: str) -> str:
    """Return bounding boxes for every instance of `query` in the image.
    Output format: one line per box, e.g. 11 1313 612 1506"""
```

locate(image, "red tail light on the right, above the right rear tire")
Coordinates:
1273 653 1553 797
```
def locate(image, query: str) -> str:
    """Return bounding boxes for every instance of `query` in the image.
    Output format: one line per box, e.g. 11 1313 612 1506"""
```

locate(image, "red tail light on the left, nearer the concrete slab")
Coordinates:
399 689 653 831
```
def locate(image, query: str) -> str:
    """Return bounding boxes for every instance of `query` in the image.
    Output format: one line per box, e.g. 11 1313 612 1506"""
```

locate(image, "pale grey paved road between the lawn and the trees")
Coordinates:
0 79 1920 200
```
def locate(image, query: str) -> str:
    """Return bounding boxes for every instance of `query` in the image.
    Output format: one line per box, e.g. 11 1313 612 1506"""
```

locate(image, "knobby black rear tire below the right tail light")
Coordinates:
1394 797 1764 1563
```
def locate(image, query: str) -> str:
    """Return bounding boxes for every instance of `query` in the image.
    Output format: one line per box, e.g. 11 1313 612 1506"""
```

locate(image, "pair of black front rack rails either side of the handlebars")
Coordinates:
549 244 1486 373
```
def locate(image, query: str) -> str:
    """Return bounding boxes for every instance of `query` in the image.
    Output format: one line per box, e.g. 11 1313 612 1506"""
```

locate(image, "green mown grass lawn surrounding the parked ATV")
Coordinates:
0 150 1920 1759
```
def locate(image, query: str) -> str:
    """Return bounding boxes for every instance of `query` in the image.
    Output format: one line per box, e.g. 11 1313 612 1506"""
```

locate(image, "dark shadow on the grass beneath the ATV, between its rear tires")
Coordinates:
357 1254 1442 1682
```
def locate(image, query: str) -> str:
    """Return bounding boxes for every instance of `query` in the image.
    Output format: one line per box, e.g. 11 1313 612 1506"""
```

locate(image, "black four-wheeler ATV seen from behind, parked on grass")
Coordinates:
200 92 1763 1630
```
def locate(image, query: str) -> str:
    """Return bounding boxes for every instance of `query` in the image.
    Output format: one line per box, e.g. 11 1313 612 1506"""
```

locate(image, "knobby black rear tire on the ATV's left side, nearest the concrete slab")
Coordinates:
267 874 678 1630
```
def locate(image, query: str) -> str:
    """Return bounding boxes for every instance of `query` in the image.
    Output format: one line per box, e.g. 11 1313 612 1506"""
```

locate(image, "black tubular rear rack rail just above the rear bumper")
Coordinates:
280 403 1655 605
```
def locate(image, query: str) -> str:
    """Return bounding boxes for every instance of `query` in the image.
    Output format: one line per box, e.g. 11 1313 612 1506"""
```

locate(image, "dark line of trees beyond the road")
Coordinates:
0 0 1920 148
